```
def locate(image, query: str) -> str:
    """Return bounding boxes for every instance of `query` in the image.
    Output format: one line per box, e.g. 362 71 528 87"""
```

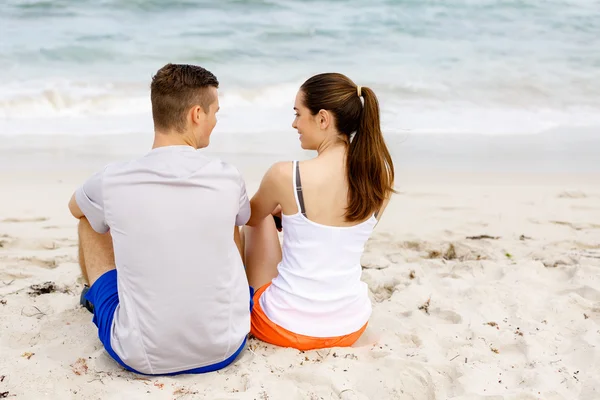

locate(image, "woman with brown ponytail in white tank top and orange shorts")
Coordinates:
244 73 394 350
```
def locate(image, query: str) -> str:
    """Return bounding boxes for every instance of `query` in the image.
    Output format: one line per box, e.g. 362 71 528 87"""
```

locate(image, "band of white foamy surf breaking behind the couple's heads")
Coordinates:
0 80 600 135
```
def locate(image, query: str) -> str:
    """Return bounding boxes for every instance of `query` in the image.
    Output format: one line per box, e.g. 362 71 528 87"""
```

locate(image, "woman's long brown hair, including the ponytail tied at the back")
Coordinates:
300 73 394 221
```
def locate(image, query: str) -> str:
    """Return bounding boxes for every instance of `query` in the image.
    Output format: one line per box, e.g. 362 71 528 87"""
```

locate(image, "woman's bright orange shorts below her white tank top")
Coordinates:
250 283 367 350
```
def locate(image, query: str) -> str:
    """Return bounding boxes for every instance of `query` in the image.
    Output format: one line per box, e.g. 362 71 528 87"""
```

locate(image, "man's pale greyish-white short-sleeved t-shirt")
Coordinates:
76 146 250 374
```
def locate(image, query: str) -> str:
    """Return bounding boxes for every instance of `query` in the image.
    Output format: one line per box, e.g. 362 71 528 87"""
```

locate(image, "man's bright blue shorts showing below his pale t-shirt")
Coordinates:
85 269 254 375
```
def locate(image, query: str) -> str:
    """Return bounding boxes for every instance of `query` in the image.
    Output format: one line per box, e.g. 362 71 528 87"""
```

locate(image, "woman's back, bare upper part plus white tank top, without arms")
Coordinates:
261 157 377 337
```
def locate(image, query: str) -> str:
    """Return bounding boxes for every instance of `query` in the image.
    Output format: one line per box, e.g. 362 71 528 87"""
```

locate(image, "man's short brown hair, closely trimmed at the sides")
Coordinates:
150 64 219 132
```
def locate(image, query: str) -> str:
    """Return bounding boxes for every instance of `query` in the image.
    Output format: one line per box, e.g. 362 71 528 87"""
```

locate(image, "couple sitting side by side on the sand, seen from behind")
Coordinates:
69 64 394 374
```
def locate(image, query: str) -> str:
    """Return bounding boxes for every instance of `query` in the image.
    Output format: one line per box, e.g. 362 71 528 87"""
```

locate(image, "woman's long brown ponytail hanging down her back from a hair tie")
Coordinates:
346 87 394 221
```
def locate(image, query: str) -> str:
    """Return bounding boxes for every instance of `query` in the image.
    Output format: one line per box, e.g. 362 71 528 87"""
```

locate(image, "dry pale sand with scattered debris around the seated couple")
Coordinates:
0 167 600 400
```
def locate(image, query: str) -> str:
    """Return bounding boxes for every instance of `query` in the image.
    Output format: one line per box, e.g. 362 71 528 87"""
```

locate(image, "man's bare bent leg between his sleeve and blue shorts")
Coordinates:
79 218 116 286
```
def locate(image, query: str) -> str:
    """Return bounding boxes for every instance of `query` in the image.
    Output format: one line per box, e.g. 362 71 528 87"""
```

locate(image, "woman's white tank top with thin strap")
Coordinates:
259 161 377 337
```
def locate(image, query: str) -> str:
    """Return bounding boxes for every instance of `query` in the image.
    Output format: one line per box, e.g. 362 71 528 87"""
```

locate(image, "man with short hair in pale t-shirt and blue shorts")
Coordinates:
69 64 251 374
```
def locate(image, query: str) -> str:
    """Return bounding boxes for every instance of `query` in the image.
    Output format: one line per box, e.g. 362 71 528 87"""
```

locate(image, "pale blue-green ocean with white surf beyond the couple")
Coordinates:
0 0 600 136
